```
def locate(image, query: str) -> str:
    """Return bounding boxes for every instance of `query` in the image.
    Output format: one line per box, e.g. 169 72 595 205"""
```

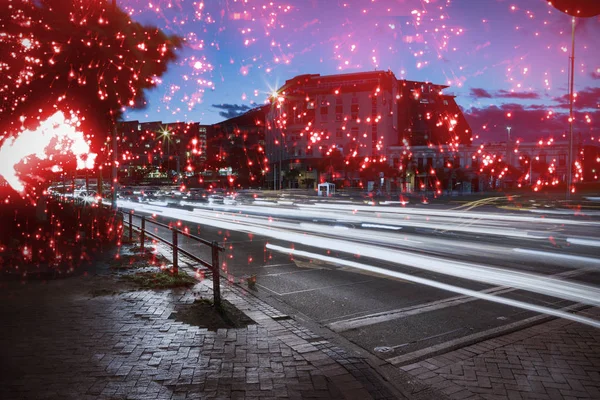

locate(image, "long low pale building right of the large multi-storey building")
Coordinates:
386 139 584 194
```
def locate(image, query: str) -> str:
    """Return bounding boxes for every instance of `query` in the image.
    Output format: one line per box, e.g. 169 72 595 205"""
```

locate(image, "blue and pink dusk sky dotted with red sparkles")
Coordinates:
123 0 600 143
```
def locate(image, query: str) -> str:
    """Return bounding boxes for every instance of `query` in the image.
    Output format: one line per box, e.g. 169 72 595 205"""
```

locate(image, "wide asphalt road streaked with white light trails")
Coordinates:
119 195 600 364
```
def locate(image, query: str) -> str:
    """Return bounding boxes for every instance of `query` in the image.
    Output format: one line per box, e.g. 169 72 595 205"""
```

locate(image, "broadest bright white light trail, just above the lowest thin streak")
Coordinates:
119 203 600 305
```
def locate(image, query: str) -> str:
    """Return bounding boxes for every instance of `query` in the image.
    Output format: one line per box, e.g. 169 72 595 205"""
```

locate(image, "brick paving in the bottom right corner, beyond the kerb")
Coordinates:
401 308 600 400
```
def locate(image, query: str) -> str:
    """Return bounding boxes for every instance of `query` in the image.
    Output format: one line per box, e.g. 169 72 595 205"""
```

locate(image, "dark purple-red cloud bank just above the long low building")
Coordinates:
464 103 600 141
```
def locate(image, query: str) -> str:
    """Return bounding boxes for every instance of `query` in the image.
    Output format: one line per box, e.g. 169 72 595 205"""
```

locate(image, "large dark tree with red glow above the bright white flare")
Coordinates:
0 0 182 193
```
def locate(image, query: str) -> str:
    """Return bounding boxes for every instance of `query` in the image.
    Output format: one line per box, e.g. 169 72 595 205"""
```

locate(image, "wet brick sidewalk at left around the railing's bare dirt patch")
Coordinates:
0 255 404 400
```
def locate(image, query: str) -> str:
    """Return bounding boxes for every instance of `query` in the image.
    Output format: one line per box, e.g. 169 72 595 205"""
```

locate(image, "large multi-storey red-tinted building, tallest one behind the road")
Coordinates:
266 71 471 188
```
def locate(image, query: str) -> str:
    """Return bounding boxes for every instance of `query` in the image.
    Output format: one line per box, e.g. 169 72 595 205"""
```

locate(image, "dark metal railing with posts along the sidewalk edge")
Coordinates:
118 211 225 307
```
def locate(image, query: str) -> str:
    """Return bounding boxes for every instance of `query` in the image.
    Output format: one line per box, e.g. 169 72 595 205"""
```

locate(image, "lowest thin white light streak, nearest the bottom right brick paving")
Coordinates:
267 244 600 328
